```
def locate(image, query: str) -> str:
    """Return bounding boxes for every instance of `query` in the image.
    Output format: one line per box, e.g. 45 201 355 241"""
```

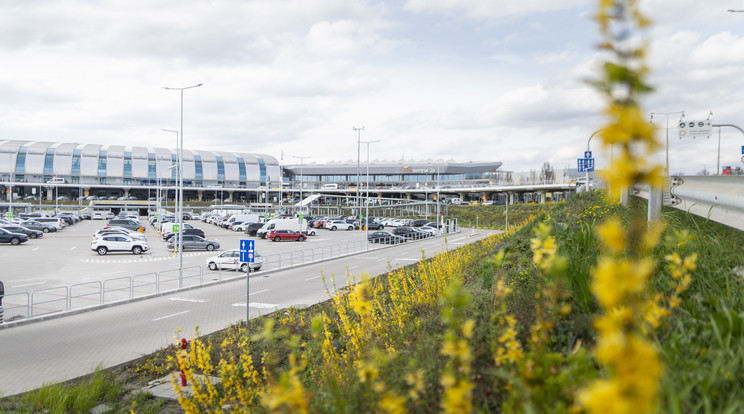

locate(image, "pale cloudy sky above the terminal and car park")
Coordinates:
0 0 744 173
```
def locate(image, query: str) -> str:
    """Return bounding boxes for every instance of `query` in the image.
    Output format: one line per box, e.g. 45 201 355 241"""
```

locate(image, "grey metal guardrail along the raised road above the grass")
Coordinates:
635 175 744 230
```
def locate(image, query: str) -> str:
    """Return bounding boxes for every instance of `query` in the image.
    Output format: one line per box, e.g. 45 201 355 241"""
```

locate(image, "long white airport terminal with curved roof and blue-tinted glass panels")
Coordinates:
0 140 501 201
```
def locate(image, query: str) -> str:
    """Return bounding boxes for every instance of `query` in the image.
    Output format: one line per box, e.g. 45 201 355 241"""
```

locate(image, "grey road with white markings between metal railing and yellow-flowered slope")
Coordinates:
0 227 500 396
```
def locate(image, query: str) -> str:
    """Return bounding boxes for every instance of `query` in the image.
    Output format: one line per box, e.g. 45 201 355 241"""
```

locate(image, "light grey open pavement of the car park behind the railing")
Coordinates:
0 217 402 294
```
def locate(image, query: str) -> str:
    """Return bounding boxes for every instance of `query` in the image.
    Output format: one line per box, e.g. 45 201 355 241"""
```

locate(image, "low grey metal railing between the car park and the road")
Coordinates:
2 228 460 323
